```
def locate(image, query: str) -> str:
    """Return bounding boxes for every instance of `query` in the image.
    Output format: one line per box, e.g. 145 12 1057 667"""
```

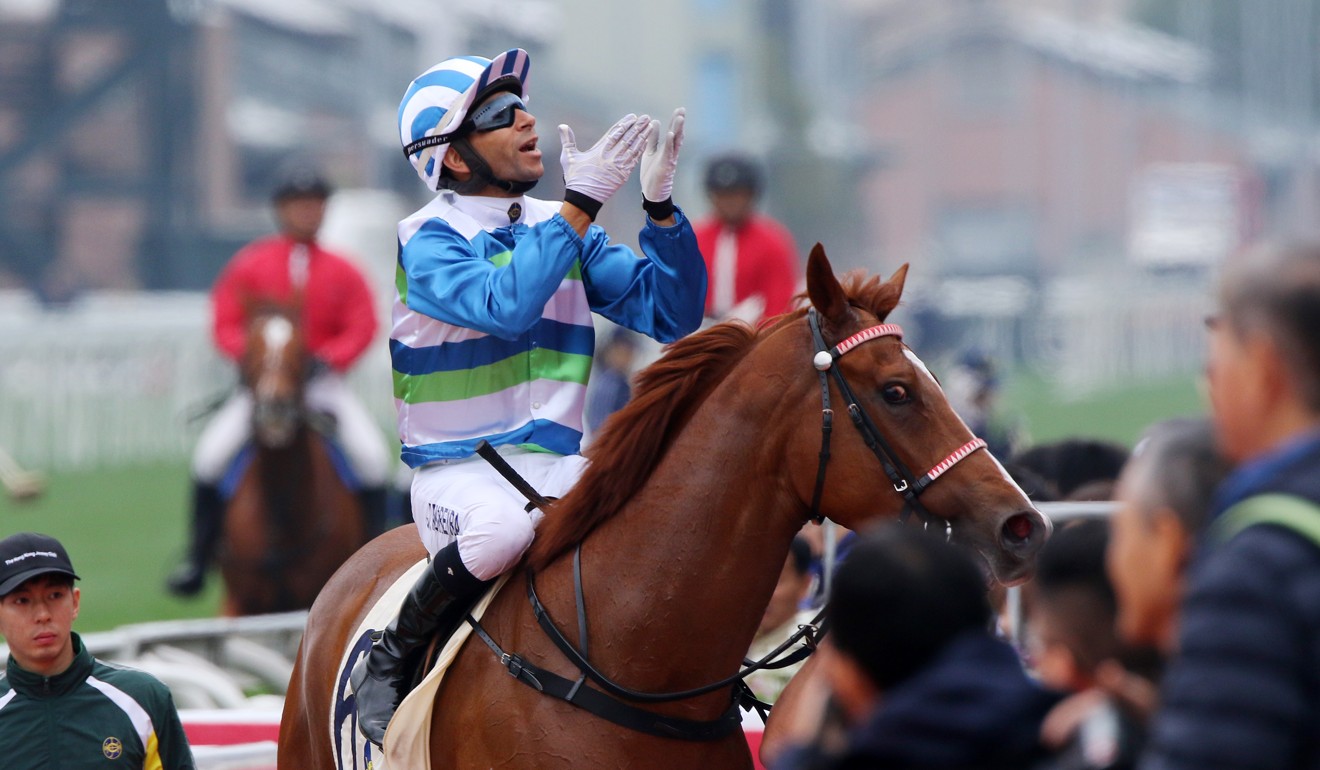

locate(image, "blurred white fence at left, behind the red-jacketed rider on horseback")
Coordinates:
0 292 393 469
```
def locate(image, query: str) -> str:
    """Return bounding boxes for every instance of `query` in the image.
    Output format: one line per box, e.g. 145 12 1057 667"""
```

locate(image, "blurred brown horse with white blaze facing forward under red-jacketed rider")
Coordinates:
219 304 367 615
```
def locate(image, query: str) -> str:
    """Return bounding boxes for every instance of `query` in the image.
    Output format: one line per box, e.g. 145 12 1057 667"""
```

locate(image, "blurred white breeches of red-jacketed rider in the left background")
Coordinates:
193 374 392 489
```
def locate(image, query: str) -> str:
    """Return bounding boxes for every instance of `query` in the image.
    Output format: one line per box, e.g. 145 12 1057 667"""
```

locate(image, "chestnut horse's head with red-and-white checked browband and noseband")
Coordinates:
789 244 1051 585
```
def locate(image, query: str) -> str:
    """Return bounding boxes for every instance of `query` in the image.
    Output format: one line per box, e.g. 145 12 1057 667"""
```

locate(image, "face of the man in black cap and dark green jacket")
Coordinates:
0 575 79 676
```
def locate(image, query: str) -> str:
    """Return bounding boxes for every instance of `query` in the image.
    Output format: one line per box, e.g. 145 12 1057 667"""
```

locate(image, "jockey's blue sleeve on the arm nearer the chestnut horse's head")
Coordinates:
572 210 706 342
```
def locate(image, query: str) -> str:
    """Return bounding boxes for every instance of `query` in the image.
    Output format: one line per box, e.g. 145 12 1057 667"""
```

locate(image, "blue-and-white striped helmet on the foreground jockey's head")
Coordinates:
399 48 531 190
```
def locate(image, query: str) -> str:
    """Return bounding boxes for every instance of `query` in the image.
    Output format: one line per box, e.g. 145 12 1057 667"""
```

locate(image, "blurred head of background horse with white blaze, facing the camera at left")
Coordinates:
242 304 308 448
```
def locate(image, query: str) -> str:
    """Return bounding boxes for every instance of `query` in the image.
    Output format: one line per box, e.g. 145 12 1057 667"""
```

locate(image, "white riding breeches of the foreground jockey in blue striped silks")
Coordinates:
412 446 586 580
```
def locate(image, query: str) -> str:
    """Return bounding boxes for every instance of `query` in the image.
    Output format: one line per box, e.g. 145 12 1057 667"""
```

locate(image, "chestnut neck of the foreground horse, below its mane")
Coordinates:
572 338 809 688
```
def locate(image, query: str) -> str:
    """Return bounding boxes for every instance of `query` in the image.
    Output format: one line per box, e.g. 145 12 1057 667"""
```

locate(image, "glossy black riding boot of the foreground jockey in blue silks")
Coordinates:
351 543 490 746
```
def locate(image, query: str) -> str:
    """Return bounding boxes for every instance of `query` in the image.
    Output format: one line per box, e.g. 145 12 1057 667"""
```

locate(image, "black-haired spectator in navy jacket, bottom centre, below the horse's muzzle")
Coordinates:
763 527 1057 770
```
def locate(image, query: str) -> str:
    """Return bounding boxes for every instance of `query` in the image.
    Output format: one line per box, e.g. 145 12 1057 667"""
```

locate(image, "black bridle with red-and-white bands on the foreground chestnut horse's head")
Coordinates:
807 308 986 532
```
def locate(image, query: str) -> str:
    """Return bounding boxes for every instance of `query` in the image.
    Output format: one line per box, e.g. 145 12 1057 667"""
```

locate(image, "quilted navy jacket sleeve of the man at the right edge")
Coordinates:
1139 526 1320 770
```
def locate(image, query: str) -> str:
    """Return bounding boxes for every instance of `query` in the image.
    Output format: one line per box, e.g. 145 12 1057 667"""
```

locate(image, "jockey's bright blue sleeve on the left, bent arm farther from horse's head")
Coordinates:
399 214 583 339
